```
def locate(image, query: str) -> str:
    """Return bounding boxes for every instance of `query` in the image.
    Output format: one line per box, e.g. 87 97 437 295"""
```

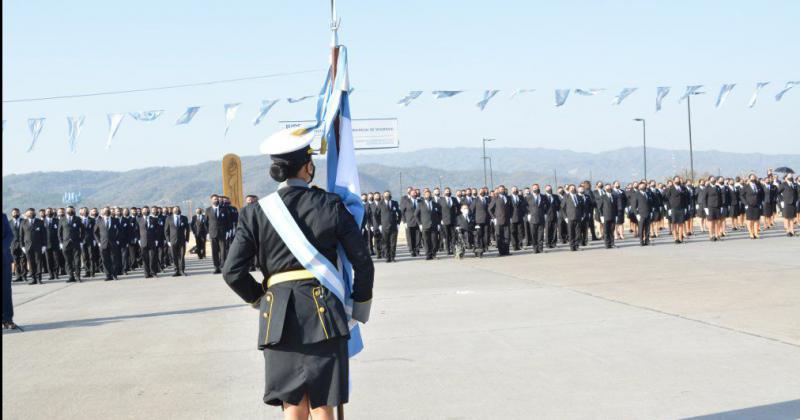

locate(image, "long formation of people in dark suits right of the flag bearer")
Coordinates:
361 171 800 261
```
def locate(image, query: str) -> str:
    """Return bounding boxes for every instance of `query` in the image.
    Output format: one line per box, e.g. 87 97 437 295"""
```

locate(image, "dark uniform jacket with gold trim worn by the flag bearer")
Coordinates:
222 184 375 349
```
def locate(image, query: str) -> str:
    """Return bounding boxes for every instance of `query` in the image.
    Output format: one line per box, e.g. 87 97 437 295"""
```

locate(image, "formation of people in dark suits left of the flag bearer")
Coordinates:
8 194 238 284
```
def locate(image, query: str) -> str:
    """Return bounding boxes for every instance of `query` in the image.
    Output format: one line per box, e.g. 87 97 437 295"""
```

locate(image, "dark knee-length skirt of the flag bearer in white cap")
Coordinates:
263 296 349 408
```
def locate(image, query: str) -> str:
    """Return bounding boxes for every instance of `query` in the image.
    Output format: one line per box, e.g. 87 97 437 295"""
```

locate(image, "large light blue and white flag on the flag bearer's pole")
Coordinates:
317 45 364 357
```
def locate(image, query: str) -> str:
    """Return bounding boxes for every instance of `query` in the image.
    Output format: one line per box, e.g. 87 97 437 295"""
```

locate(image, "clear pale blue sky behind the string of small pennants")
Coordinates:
2 0 800 175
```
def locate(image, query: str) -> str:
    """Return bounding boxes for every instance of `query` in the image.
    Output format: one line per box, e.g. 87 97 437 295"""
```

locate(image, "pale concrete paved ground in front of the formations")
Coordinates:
3 228 800 419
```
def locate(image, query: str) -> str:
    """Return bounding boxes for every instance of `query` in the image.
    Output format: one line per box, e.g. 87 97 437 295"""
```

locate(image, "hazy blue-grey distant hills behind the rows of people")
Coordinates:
3 148 800 211
